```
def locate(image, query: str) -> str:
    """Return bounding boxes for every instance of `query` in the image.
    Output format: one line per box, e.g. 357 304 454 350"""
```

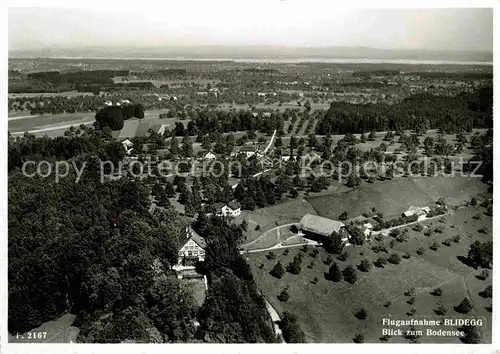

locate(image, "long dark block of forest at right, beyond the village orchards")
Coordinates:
316 87 493 135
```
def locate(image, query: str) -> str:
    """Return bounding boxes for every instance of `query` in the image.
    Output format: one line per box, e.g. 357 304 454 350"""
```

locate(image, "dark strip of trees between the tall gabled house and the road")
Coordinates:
194 216 275 343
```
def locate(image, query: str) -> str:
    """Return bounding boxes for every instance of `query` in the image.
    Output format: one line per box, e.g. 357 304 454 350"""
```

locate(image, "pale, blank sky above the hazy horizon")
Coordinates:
8 0 493 51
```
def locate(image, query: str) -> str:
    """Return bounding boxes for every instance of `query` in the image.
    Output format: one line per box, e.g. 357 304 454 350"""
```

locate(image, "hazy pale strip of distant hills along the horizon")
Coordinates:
9 46 493 62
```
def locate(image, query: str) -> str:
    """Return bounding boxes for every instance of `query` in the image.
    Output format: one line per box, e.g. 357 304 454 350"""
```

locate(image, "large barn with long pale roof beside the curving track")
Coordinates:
299 214 348 241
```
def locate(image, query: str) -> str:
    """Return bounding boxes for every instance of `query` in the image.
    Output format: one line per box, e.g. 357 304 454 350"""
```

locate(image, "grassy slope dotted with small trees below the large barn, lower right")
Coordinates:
246 202 492 344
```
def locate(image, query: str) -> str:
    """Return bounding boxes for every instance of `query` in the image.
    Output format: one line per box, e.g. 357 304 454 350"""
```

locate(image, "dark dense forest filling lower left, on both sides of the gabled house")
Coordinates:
8 130 275 343
